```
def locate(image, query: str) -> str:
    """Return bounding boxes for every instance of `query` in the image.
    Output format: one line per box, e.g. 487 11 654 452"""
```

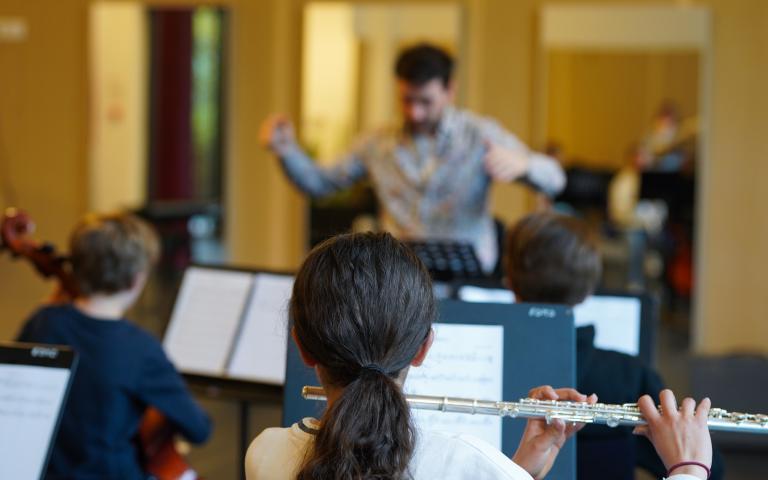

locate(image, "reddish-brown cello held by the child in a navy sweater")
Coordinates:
0 208 200 480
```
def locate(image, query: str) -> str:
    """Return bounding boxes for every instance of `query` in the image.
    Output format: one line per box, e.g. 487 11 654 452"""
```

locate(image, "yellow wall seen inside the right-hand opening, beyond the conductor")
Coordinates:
546 50 699 170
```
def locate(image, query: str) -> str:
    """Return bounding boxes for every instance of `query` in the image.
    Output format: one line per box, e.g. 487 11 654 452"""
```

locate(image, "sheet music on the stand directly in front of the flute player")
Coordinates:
405 323 504 449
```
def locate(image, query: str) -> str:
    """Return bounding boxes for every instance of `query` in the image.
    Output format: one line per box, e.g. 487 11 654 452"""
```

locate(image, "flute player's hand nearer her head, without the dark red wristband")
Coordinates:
512 385 597 479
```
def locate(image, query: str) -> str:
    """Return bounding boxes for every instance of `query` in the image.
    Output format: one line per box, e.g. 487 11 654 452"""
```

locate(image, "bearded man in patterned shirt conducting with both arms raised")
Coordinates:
260 44 565 272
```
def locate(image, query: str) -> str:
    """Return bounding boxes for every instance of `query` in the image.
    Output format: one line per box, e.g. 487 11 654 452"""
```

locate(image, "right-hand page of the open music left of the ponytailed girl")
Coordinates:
227 273 293 385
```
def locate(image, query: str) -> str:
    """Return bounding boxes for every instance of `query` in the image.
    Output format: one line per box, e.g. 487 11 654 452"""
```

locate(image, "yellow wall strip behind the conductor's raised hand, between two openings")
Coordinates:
225 0 306 269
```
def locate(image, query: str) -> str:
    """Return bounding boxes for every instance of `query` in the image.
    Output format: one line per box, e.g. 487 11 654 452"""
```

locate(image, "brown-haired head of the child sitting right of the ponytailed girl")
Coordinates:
504 213 602 305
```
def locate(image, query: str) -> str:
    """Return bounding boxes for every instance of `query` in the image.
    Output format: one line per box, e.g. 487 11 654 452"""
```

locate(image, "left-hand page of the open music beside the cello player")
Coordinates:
163 267 253 376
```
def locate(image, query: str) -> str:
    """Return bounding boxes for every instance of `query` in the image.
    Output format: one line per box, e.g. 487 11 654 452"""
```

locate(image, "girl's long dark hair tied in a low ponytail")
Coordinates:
289 233 437 480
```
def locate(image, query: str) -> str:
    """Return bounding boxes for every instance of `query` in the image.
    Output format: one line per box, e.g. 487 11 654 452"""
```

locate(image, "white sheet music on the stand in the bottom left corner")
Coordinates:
0 365 70 480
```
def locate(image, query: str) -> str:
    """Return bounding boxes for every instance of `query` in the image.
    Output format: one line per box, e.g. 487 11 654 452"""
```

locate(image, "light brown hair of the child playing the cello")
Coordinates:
69 213 160 297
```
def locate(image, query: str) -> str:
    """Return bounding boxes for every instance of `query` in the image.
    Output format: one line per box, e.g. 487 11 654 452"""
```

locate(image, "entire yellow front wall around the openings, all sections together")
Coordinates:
0 0 768 352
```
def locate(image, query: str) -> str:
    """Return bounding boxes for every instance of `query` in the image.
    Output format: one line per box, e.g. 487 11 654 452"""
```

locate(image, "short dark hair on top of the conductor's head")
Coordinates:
395 43 453 87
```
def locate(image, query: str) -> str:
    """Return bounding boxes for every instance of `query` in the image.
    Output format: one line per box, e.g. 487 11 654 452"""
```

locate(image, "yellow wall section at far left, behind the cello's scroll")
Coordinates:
0 0 88 339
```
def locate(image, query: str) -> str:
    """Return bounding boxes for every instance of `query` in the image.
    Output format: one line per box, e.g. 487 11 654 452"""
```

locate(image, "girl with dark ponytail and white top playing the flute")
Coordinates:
245 233 712 480
